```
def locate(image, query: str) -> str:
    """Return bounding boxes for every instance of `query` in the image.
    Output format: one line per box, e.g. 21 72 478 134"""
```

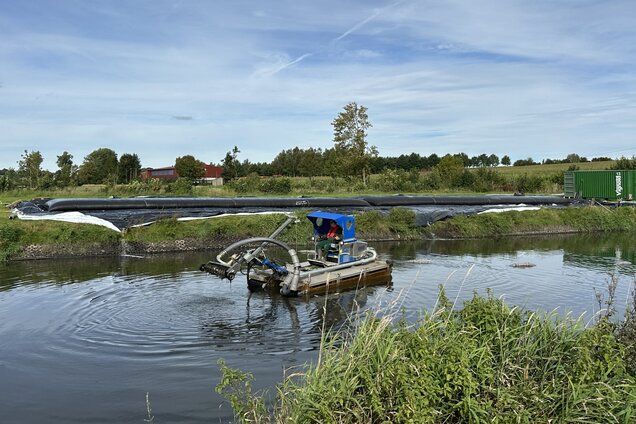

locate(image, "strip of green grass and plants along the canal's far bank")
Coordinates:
0 198 636 261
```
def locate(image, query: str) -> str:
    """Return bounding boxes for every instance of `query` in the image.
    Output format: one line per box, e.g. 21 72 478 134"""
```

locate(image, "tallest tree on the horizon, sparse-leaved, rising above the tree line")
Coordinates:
331 102 378 185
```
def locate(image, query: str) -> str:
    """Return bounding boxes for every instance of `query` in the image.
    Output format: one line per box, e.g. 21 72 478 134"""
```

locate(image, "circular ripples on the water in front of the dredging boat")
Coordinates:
40 273 326 360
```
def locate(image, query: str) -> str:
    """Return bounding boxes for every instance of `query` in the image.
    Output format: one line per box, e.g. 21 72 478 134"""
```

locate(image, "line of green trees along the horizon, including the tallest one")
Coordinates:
0 102 636 191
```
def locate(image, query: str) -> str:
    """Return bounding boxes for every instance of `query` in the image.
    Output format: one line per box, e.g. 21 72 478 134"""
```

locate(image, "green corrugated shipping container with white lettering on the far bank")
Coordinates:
563 170 636 200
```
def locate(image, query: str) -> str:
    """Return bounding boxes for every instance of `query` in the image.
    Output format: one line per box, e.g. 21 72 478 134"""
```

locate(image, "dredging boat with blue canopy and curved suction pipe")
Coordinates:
200 211 392 297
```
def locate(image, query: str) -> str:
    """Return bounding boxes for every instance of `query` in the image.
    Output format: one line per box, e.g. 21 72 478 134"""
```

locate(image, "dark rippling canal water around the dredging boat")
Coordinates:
0 235 636 423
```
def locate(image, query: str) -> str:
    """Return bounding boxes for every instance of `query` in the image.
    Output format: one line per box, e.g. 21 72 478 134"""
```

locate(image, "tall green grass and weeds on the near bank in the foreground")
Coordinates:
217 295 636 423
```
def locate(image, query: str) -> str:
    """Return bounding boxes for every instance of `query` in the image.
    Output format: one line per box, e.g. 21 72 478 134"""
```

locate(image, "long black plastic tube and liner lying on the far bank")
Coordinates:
17 195 572 229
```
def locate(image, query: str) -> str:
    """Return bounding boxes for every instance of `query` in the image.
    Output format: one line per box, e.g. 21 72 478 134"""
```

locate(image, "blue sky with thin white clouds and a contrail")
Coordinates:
0 0 636 170
